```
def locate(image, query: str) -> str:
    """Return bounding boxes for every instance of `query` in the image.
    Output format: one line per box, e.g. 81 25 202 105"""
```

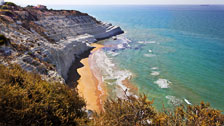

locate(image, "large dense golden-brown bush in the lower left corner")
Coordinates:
0 65 87 125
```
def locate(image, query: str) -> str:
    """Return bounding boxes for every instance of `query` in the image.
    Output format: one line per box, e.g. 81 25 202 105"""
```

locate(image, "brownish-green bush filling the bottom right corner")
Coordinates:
164 102 224 126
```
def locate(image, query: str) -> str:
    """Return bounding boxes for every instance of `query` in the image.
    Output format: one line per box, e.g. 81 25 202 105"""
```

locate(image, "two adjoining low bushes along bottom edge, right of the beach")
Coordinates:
91 96 224 126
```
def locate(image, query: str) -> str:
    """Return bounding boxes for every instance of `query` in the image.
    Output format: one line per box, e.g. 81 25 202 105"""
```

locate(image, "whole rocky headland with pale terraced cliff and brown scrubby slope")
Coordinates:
0 5 123 82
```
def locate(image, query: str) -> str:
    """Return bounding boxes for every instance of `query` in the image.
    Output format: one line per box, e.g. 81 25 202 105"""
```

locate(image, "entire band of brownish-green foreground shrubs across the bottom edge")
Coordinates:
0 65 224 126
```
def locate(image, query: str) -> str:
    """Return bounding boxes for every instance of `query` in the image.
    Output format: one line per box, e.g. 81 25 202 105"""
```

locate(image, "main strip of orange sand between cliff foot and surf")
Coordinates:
77 43 103 113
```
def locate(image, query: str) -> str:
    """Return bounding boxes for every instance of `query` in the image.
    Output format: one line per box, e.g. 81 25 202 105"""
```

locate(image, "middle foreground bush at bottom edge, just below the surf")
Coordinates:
92 96 160 126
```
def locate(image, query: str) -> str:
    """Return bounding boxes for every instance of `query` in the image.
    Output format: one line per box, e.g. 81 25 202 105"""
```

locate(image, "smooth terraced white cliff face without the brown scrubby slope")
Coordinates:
36 16 123 79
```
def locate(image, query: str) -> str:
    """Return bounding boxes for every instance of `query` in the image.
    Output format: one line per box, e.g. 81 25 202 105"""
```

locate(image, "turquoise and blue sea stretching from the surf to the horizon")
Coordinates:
53 5 224 110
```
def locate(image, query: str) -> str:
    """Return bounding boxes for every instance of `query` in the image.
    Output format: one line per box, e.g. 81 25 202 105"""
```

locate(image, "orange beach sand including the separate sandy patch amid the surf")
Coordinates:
77 43 138 113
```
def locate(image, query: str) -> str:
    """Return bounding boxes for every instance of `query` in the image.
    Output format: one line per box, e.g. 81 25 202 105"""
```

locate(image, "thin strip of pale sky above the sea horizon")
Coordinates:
5 0 224 5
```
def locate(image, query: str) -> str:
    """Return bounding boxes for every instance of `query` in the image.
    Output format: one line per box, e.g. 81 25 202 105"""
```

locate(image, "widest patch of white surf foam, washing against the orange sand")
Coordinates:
90 50 132 98
